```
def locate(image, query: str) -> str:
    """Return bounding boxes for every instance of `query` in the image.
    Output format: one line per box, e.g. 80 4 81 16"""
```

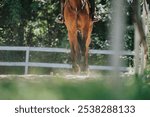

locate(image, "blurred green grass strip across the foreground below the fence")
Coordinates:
0 72 150 100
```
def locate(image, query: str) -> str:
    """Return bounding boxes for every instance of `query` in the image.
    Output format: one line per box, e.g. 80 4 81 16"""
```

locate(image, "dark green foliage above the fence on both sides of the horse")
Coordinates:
0 0 132 49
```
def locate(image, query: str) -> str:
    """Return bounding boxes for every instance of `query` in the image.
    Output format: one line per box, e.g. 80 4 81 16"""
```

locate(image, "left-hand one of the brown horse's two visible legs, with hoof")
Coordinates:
68 32 80 73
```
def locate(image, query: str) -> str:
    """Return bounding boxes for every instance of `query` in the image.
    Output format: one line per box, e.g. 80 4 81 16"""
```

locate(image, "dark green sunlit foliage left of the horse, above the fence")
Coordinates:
0 0 67 47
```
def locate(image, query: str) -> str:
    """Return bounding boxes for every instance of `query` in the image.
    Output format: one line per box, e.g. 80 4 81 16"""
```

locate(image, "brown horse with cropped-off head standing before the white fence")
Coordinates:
64 0 93 72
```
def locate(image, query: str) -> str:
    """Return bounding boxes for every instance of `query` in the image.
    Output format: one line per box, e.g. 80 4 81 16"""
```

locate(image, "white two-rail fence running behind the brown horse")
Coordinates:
0 46 134 74
